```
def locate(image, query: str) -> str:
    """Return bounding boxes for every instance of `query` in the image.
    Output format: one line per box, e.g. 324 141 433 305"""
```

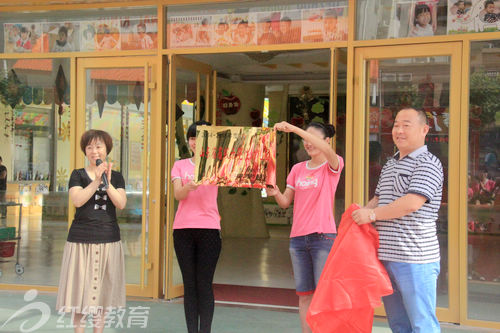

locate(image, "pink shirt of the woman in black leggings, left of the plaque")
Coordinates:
171 158 220 229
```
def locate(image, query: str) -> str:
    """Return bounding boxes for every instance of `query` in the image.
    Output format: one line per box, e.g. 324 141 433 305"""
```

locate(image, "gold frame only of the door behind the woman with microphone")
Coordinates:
75 57 162 297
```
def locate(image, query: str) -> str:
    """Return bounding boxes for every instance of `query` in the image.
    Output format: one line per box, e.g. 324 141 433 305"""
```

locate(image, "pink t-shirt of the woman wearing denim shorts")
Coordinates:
286 155 344 237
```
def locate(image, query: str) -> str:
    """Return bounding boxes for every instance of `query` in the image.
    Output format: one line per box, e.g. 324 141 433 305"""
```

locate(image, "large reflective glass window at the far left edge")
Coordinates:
0 59 71 286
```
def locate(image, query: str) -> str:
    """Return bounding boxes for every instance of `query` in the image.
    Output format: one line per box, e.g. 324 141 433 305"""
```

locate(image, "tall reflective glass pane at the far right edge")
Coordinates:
464 41 500 321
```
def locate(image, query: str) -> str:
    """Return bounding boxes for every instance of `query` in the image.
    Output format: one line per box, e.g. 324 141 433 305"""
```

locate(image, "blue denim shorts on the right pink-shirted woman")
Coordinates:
290 233 337 296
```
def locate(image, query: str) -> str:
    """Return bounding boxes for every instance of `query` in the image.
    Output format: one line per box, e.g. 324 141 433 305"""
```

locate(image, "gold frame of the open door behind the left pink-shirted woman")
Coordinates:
163 54 211 299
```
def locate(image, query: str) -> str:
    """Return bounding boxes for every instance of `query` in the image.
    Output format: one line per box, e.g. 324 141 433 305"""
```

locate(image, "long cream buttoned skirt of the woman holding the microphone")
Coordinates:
56 241 125 314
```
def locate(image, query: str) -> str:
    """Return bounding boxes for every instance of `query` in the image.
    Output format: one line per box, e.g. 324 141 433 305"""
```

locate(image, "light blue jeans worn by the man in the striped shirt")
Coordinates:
382 261 441 333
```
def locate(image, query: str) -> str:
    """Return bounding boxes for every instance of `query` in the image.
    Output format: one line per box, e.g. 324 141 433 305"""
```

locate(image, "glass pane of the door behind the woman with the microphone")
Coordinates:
85 68 149 284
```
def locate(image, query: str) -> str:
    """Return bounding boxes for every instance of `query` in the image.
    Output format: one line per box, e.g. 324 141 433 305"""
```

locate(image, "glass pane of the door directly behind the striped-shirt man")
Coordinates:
366 56 450 308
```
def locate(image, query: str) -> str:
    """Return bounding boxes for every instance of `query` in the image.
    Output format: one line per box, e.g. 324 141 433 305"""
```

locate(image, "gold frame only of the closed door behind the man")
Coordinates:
352 42 462 323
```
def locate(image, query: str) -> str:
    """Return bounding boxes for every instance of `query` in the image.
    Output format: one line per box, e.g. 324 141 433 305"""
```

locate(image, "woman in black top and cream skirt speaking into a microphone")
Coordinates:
56 130 127 333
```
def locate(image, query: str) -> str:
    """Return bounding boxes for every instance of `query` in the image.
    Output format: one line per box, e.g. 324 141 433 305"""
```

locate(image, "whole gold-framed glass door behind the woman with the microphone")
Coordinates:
75 57 159 296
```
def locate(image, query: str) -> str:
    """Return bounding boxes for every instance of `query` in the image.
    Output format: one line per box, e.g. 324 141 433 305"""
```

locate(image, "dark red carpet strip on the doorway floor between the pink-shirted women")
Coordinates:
214 284 299 306
